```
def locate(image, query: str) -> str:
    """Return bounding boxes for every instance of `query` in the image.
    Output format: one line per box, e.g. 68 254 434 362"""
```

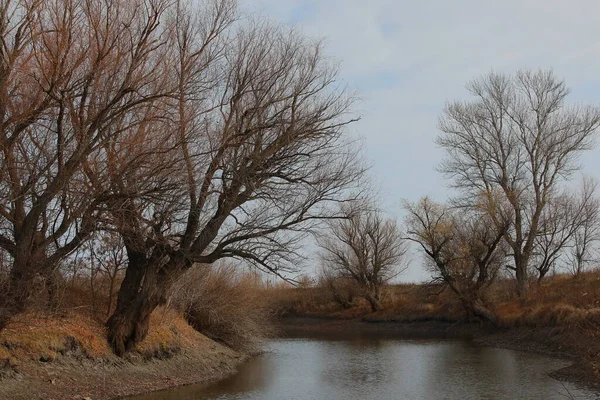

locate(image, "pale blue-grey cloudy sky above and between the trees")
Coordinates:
240 0 600 281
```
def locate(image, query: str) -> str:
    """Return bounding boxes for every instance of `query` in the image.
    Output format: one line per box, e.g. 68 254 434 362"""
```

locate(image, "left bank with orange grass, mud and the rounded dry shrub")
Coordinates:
0 267 272 400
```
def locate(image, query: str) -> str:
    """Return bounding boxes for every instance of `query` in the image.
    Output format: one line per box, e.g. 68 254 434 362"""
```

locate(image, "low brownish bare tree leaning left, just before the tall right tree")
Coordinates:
405 197 508 325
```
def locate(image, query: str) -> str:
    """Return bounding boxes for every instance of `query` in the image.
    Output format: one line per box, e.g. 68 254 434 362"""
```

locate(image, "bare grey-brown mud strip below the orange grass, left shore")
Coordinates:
0 343 249 400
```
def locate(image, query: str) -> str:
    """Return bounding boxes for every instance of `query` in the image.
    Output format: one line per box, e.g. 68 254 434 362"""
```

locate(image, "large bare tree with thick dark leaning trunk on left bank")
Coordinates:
100 8 362 354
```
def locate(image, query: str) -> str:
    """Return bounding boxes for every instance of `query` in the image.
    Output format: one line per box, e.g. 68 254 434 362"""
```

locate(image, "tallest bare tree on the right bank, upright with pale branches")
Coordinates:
438 71 600 295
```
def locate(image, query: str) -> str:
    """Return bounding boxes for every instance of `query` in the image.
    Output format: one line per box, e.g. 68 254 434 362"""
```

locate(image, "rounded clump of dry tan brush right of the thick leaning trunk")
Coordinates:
171 264 273 352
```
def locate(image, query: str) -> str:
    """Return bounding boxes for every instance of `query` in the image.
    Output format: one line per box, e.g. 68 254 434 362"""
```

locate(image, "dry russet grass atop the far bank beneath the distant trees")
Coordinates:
271 271 600 329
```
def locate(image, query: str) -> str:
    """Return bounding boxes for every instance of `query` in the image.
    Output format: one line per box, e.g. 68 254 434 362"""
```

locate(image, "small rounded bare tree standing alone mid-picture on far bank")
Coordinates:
319 203 407 311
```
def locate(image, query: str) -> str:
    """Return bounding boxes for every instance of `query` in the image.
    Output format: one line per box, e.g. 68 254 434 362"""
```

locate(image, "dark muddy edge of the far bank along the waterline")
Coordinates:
280 316 600 392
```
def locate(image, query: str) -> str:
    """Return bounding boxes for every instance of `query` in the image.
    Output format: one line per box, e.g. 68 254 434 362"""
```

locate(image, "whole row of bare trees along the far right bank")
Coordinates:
321 70 600 324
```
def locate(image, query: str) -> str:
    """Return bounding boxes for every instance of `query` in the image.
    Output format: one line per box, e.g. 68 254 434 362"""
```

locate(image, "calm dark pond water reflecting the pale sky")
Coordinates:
132 337 600 400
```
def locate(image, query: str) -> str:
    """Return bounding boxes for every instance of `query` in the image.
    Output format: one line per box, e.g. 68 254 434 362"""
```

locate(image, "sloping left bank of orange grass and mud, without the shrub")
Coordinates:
0 310 249 400
